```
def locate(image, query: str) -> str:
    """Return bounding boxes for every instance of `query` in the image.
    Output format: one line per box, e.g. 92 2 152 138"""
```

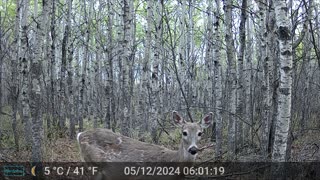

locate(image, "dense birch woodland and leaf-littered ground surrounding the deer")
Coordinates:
0 0 320 162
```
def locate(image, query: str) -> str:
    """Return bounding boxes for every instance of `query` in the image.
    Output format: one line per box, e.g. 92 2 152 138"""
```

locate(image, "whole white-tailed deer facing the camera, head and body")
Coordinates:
77 111 213 162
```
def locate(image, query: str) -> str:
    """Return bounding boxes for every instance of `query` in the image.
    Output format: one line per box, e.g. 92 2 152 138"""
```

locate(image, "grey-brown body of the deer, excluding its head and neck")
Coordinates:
79 129 188 162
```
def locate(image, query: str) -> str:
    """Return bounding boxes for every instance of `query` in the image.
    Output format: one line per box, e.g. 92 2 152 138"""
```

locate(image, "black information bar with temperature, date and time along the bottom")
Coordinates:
0 162 320 180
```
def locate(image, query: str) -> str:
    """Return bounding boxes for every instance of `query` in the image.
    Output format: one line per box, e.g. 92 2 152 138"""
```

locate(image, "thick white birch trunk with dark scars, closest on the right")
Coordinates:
272 0 292 162
